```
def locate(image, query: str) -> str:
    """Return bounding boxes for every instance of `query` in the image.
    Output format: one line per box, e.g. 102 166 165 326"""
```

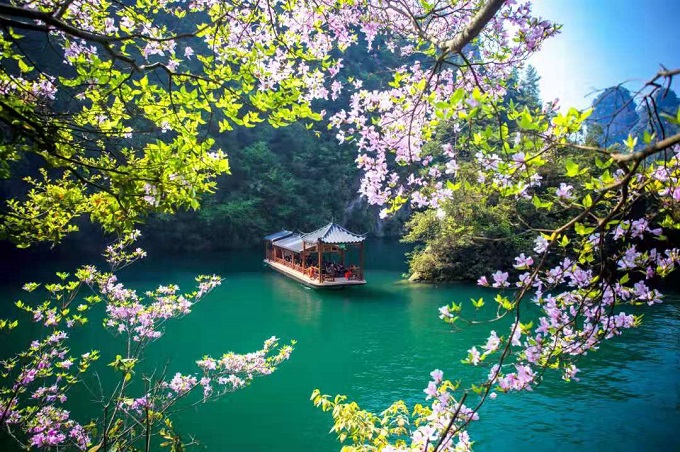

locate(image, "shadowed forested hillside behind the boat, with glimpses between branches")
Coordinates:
0 41 407 252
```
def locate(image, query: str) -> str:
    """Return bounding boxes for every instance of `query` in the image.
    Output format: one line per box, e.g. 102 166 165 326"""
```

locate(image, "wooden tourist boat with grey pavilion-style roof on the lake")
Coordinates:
264 223 366 288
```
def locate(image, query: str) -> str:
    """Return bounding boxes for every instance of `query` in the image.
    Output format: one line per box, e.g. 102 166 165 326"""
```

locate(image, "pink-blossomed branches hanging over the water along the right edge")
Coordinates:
415 142 680 444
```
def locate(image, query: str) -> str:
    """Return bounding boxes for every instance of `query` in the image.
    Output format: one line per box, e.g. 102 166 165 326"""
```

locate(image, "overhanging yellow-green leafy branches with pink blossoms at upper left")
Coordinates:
0 2 366 247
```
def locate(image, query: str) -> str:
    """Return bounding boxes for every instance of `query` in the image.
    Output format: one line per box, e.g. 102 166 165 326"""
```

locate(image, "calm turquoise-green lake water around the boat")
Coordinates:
0 238 680 451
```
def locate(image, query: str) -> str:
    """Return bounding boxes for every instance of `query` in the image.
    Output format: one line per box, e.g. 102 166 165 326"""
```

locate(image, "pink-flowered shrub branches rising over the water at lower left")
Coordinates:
0 232 292 450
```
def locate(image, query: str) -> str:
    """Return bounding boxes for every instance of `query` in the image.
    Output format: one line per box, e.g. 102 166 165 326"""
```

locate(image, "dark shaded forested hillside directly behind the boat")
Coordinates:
145 124 400 250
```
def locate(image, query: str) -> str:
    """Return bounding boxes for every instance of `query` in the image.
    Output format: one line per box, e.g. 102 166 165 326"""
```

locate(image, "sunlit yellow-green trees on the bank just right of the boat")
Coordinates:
403 66 562 281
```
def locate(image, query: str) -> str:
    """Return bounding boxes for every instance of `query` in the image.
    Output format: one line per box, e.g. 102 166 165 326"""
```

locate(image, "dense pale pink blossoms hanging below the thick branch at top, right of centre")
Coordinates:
322 2 557 216
